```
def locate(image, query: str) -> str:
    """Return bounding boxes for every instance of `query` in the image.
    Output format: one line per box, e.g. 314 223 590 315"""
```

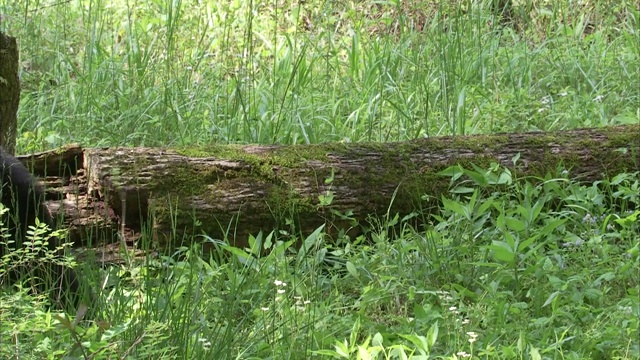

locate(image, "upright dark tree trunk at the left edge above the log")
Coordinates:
0 32 20 154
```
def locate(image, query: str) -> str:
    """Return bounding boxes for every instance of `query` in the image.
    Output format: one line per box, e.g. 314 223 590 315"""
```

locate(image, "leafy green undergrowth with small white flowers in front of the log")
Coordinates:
0 166 640 359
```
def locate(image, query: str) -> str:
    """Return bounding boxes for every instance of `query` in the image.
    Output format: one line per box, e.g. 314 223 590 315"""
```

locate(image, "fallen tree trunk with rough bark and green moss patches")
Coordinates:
47 125 640 246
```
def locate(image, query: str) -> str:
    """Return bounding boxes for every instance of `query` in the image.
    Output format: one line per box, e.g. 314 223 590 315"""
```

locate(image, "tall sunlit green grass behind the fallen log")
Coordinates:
0 0 640 150
